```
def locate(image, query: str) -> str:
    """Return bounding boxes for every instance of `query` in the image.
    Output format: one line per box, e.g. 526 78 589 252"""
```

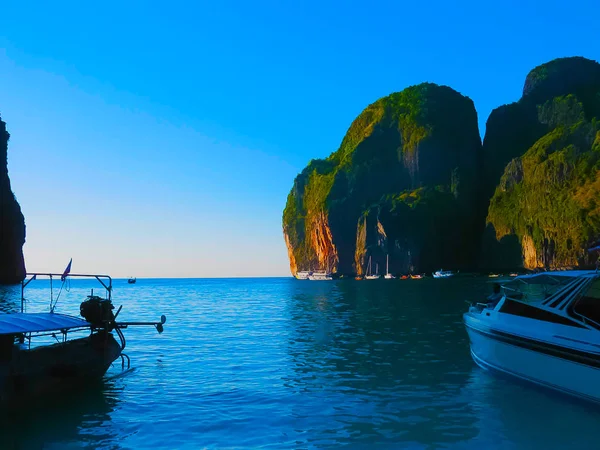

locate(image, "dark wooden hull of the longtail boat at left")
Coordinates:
0 333 121 404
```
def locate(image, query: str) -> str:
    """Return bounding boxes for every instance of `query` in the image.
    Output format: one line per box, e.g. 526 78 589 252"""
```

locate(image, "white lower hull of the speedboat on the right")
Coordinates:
465 318 600 403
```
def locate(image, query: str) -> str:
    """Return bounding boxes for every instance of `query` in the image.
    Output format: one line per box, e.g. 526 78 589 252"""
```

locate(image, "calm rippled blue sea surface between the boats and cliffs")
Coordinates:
0 278 600 449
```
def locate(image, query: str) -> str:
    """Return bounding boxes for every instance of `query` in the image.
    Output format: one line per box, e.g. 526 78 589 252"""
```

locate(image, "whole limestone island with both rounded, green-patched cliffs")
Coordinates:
283 57 600 276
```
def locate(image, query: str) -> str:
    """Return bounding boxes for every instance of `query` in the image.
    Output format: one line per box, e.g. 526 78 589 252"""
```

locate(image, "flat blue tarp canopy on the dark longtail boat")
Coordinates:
0 313 90 335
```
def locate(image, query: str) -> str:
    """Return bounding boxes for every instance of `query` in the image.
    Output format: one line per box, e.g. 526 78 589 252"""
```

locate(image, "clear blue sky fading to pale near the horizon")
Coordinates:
0 0 600 277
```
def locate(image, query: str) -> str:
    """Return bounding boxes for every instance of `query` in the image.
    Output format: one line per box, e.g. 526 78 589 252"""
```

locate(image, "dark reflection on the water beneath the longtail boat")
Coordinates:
0 382 120 449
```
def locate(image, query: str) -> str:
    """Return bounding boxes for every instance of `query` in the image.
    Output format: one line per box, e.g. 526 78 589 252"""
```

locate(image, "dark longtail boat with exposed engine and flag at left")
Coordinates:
0 267 166 405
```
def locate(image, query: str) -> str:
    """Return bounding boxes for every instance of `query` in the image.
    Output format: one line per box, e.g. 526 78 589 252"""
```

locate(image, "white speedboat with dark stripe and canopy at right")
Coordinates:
463 271 600 402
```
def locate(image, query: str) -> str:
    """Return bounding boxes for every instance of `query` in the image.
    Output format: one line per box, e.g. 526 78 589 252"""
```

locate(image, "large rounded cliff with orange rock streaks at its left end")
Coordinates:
283 83 484 274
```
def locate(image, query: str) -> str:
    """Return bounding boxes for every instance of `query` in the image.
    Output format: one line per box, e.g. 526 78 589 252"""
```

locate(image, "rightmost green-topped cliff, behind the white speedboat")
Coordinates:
483 58 600 268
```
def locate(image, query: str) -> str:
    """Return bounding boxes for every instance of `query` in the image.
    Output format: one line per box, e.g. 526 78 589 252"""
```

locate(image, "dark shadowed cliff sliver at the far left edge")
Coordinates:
0 118 25 284
